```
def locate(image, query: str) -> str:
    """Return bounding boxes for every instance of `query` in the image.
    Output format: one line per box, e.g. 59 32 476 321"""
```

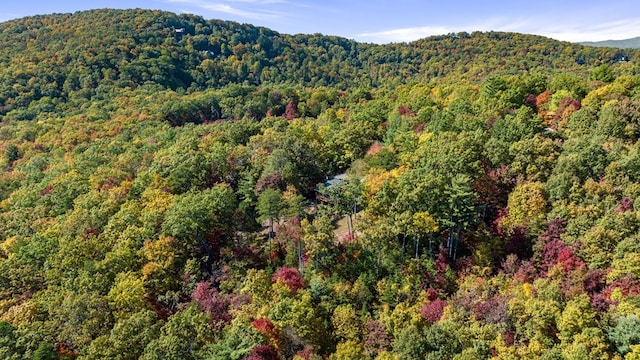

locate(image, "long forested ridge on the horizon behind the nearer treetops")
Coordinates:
0 9 638 121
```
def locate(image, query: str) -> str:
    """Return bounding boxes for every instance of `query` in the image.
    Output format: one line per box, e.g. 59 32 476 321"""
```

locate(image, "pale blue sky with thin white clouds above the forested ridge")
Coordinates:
0 0 640 43
